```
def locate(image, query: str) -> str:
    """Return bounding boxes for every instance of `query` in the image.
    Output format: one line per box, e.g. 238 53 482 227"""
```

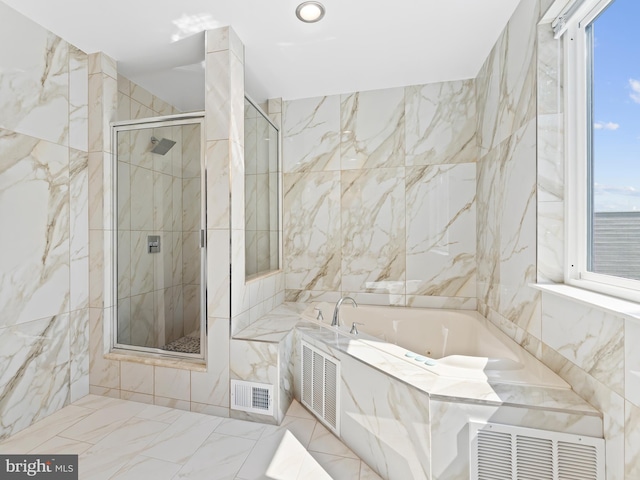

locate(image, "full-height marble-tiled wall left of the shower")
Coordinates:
0 3 89 438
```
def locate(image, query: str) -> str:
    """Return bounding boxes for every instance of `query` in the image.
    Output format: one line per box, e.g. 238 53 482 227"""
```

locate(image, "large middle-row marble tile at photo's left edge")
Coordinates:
0 130 70 326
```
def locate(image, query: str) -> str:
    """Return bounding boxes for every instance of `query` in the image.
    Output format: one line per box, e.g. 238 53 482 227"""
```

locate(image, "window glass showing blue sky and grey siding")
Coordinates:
587 0 640 280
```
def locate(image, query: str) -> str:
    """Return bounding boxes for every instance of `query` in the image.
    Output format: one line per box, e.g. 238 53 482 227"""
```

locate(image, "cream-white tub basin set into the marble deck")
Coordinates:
303 302 570 388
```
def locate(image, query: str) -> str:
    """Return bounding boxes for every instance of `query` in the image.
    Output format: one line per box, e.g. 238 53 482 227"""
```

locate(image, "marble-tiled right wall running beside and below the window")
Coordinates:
476 0 640 480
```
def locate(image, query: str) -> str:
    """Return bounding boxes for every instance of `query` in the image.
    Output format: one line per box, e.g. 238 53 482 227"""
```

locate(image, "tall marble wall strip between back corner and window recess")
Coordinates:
476 0 540 348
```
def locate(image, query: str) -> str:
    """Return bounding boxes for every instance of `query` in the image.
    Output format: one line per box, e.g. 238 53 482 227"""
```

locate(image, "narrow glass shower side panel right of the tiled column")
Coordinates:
244 99 280 278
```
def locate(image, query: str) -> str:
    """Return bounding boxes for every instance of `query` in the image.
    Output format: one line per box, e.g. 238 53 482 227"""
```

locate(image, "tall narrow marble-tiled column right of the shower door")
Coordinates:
191 27 244 415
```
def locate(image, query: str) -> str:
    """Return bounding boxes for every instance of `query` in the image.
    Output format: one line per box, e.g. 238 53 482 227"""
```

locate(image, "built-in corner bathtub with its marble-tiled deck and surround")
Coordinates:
230 303 603 480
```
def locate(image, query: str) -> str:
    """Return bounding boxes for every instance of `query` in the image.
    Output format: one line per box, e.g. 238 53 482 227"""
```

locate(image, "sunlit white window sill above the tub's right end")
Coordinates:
530 283 640 320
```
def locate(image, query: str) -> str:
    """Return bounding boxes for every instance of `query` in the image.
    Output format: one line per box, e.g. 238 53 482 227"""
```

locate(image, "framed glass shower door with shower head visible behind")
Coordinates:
113 115 206 358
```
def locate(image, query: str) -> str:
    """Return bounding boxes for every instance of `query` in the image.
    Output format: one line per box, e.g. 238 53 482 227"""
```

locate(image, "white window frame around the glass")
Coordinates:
562 0 640 302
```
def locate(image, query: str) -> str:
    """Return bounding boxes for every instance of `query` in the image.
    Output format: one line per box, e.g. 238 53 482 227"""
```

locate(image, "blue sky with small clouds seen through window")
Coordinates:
594 0 640 211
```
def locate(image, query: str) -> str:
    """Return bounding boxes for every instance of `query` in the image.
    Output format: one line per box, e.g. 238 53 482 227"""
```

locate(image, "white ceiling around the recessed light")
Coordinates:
2 0 519 111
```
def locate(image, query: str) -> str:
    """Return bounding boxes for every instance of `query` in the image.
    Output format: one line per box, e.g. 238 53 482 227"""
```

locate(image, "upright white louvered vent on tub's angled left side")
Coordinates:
302 342 340 435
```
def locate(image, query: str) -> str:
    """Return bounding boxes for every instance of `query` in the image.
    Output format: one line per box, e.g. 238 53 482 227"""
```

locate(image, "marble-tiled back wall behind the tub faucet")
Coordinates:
283 80 478 309
